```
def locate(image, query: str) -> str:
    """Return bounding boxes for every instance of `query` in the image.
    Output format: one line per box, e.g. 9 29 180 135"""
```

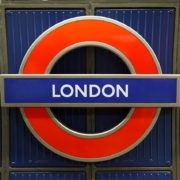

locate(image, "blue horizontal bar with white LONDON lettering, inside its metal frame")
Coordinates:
4 78 177 104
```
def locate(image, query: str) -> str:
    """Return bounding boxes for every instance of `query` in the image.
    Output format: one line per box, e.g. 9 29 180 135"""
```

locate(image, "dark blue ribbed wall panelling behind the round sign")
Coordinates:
6 9 175 180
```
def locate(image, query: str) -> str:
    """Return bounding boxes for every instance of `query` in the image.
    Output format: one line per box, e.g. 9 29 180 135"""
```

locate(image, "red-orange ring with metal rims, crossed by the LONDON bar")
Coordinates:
19 16 161 162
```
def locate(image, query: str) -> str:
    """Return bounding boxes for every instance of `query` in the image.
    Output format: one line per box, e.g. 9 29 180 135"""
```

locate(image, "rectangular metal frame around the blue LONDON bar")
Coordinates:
0 74 180 107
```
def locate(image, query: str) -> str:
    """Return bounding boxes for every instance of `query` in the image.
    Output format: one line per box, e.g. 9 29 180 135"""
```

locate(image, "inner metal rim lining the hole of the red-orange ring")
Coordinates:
17 18 160 159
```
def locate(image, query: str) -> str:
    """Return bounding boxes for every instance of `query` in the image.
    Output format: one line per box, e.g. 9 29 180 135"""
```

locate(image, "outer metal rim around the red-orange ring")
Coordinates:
14 16 162 162
